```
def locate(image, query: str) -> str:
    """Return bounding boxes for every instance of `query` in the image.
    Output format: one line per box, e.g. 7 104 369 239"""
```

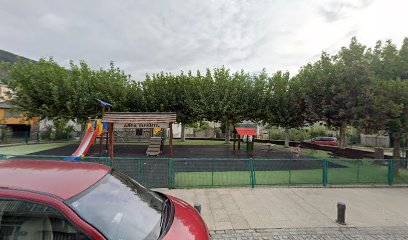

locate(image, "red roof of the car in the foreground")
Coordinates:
0 159 111 200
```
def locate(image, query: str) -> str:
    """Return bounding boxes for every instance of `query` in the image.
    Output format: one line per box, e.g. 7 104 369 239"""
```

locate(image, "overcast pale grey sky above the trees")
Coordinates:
0 0 408 80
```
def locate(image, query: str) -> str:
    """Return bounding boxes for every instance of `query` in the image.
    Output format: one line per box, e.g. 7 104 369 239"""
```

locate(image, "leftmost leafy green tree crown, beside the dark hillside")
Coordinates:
6 59 70 119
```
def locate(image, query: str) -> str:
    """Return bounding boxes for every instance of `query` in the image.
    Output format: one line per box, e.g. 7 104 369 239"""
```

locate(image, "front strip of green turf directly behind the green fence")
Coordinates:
174 159 408 188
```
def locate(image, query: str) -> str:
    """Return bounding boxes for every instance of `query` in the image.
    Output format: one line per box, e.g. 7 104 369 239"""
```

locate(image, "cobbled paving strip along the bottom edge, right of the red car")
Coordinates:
211 226 408 240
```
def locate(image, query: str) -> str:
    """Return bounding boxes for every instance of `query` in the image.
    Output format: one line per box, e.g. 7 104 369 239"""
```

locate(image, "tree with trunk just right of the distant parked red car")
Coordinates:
299 37 371 148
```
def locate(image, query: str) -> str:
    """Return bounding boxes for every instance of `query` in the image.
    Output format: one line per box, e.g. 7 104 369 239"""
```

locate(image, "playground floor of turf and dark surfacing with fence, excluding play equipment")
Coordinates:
0 140 408 188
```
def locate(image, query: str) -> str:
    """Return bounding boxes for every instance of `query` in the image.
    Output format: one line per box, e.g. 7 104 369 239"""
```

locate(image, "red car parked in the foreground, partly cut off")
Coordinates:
0 160 210 240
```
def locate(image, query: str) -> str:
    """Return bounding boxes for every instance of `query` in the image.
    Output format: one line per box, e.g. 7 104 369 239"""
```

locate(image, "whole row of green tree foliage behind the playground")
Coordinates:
0 37 408 155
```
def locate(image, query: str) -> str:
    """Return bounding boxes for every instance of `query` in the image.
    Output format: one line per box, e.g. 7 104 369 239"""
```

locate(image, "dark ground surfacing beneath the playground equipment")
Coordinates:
29 145 344 172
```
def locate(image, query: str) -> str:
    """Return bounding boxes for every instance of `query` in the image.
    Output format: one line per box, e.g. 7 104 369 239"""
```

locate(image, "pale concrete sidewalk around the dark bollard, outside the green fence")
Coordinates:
159 187 408 231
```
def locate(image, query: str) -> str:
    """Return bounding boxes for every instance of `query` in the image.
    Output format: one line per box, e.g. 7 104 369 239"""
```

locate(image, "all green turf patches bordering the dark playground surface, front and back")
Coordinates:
0 139 408 188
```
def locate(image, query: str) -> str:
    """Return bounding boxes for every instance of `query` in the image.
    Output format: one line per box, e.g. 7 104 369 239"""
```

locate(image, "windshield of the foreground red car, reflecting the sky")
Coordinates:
67 171 163 240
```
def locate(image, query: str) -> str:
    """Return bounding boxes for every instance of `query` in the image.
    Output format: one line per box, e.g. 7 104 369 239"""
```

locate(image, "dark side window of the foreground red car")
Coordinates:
0 199 90 240
